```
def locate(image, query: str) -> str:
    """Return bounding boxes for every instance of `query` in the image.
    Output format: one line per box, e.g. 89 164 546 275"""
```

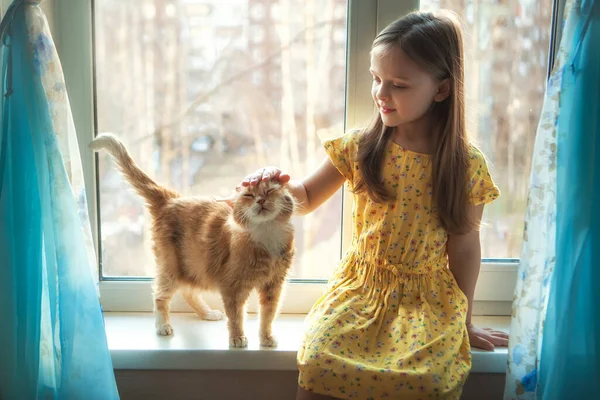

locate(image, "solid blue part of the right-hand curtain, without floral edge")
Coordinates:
539 0 600 399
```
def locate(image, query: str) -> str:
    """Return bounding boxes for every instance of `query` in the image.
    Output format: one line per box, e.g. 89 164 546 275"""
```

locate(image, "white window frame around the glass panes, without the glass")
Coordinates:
48 0 565 315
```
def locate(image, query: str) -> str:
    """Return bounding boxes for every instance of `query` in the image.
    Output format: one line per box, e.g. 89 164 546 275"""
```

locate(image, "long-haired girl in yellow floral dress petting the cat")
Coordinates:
227 12 508 400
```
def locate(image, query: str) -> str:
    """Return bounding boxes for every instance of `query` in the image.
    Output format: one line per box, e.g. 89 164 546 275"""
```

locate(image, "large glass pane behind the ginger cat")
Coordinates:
95 0 346 278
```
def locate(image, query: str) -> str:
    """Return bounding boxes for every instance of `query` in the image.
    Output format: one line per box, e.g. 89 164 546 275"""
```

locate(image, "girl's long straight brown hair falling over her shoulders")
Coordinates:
355 11 474 233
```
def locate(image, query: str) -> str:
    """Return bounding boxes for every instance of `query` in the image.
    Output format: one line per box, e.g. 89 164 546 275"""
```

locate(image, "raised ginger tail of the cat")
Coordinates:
90 133 179 209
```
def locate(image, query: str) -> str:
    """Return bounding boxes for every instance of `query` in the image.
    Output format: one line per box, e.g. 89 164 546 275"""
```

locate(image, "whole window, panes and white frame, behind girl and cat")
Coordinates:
55 0 551 314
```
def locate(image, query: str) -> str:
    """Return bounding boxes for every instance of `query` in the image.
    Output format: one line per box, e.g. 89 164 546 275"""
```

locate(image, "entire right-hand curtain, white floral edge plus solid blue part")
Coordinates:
504 0 600 400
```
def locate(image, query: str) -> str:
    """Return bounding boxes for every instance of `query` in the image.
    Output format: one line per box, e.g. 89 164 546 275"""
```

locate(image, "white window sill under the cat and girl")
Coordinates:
104 312 510 373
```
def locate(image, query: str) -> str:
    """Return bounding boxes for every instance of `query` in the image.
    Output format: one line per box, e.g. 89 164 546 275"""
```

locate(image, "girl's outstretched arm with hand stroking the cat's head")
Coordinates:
227 157 346 215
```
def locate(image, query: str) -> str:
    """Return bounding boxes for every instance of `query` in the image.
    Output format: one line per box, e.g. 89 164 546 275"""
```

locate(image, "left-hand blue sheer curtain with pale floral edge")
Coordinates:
0 0 119 400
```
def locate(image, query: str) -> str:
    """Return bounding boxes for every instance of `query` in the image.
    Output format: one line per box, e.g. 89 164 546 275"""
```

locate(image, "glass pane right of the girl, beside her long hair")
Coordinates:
421 0 552 258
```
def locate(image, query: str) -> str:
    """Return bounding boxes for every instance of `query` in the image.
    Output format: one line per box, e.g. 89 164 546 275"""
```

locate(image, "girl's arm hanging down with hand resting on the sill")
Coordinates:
448 204 508 350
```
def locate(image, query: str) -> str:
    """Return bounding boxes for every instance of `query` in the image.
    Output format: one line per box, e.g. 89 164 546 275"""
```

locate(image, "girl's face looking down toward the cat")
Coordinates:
370 46 449 127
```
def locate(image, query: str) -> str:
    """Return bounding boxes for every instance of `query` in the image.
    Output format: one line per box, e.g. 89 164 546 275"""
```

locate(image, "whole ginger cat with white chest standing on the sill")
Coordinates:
90 134 295 347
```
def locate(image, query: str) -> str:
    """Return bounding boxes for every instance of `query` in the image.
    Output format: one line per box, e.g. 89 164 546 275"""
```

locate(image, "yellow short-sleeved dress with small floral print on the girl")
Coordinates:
298 133 500 400
